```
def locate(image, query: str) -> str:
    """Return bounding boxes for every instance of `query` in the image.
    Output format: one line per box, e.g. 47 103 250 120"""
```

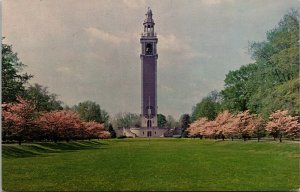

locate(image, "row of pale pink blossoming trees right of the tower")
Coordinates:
187 110 300 142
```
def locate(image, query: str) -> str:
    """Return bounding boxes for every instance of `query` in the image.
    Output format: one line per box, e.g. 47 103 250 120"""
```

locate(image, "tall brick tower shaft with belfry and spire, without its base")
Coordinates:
140 8 158 128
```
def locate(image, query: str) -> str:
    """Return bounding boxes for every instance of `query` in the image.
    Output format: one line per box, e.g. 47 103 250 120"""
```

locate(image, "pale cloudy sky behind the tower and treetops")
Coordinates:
2 0 299 118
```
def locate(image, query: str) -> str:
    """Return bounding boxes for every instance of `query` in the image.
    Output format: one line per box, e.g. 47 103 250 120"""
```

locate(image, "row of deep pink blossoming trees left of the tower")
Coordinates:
2 97 110 144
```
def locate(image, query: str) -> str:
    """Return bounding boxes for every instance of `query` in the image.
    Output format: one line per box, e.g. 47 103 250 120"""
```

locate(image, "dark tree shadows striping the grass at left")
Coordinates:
2 140 107 158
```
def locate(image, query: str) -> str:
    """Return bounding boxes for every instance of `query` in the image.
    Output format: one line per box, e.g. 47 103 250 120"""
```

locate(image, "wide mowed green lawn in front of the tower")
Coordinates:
2 139 300 191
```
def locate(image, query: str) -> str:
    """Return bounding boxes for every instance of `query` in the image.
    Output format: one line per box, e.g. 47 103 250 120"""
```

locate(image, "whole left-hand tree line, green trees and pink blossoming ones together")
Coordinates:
1 38 116 144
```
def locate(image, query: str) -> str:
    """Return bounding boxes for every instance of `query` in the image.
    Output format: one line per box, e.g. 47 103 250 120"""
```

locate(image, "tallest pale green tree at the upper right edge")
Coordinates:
250 10 299 84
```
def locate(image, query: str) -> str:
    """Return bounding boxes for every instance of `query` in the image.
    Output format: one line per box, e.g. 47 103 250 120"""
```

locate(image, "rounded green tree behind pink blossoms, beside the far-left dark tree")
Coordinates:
25 84 63 111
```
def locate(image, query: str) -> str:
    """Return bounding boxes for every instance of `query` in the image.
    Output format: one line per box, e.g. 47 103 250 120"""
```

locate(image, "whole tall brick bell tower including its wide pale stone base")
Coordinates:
117 8 181 137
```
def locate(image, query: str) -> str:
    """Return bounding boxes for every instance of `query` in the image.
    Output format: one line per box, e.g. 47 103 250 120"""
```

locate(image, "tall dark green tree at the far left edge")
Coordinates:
1 38 33 103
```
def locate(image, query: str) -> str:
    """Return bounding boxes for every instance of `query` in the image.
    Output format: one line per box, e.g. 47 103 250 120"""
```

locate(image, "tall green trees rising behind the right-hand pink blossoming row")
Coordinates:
191 10 300 140
